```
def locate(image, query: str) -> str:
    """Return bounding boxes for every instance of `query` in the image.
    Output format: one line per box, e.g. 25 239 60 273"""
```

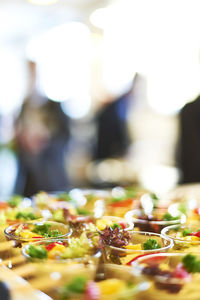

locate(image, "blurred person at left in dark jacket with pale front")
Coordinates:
14 61 69 197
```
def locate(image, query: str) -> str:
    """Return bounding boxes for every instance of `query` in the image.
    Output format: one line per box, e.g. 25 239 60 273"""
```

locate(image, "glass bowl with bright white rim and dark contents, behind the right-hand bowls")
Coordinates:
125 209 186 233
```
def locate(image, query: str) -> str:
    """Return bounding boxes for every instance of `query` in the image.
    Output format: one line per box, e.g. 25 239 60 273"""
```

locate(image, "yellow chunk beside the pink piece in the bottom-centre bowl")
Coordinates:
97 279 126 295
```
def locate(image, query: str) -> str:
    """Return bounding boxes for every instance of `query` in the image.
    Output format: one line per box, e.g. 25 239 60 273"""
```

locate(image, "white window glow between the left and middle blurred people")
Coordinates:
28 22 91 117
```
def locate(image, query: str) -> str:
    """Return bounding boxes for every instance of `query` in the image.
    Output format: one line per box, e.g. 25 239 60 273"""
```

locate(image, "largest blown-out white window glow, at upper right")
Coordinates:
95 0 200 115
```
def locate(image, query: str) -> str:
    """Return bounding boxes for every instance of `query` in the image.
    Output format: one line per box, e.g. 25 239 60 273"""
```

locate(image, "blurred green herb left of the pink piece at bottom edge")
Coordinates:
60 276 87 299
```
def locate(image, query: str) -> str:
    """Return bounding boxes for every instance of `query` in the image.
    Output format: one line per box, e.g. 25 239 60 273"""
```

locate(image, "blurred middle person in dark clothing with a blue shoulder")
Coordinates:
94 73 138 160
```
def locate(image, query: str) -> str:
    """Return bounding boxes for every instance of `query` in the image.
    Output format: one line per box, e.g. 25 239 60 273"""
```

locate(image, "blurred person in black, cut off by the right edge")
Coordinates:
177 96 200 183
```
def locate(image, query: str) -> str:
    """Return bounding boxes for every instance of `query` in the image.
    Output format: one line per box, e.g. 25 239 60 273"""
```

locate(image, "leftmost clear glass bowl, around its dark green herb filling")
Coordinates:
4 221 72 242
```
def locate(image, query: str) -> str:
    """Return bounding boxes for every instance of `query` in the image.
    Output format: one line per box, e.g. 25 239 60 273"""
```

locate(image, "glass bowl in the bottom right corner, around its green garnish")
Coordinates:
132 253 200 300
